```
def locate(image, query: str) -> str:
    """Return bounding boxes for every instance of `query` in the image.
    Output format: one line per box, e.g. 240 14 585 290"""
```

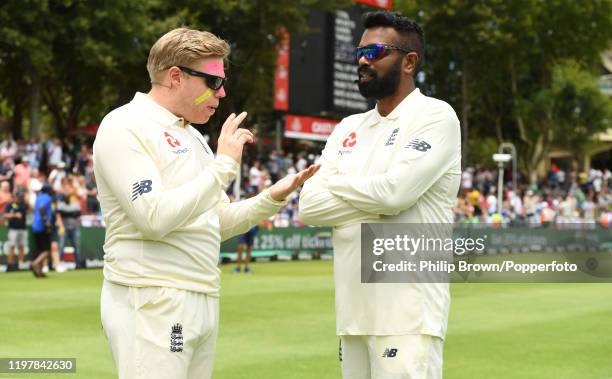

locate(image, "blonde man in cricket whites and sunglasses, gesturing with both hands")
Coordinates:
94 28 317 379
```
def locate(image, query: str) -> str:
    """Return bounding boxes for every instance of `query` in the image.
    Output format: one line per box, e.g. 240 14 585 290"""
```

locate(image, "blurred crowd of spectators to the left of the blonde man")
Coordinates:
0 138 100 270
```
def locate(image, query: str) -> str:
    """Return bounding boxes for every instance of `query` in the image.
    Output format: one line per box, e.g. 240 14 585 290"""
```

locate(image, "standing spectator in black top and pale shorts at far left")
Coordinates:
4 191 29 271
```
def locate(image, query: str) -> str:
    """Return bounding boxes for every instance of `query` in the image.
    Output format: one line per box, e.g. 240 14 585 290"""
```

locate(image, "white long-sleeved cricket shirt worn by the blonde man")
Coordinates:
94 93 285 296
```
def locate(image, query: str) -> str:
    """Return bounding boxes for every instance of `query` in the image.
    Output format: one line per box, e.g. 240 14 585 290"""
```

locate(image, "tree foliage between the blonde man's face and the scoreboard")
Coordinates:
158 0 351 145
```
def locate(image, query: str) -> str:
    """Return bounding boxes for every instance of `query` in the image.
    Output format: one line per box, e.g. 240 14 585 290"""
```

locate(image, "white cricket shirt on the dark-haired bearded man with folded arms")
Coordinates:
299 89 461 338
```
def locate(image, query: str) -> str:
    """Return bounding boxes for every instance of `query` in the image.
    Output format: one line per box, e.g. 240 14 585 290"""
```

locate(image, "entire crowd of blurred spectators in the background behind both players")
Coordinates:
0 138 612 272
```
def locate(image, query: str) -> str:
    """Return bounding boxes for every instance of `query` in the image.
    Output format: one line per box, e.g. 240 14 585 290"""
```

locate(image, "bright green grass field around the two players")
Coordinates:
0 261 612 379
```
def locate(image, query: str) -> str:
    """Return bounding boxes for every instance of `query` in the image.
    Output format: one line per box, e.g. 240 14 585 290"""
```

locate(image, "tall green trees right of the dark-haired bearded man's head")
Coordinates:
398 0 612 182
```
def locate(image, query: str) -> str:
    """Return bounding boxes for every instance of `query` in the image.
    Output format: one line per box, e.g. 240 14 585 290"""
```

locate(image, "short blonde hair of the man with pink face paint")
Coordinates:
147 28 230 81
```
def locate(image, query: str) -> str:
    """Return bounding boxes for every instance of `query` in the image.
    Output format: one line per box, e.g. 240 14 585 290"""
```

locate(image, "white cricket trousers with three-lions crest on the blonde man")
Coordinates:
100 280 219 379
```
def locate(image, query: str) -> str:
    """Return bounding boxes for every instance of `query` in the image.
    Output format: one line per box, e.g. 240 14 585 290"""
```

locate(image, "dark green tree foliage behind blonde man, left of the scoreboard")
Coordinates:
0 0 350 140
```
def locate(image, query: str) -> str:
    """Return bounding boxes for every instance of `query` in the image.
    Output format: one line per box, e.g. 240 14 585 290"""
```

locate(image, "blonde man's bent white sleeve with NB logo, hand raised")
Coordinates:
94 128 238 240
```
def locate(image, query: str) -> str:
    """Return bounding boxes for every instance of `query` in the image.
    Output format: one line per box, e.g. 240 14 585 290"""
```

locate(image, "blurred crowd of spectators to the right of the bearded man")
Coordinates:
454 164 612 226
